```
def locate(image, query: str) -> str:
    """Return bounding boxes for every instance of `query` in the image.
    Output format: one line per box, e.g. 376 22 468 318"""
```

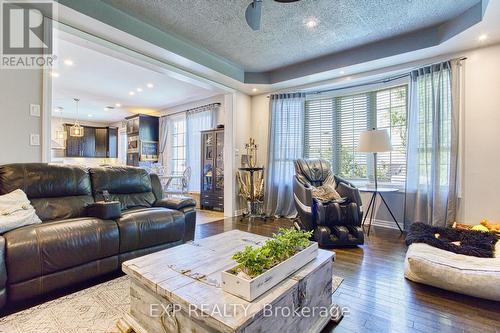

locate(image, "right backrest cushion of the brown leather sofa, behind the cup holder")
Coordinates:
90 167 156 210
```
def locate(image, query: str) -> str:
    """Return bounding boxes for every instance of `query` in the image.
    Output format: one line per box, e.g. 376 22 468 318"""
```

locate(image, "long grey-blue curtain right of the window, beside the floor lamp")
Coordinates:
405 60 460 227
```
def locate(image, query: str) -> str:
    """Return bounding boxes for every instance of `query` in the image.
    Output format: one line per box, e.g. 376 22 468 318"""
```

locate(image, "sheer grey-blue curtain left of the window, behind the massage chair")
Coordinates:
265 93 305 217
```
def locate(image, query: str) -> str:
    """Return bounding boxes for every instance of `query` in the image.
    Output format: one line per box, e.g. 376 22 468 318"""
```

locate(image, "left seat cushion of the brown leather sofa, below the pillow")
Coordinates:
3 218 119 284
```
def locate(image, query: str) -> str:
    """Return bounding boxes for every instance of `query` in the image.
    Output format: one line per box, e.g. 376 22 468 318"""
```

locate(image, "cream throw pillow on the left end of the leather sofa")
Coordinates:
0 190 42 234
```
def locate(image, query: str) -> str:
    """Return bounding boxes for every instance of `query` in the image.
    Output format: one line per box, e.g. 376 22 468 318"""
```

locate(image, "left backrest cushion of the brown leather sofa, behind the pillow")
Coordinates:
0 163 94 221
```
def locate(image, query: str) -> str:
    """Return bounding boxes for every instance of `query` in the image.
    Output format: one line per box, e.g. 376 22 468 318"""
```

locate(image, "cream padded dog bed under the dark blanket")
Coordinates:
405 242 500 301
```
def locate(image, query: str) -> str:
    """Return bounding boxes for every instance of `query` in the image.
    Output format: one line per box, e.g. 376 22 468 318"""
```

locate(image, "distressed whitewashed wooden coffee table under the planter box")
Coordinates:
122 230 335 333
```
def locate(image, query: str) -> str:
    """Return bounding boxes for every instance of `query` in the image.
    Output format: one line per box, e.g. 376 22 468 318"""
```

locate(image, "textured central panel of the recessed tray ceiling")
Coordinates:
102 0 480 72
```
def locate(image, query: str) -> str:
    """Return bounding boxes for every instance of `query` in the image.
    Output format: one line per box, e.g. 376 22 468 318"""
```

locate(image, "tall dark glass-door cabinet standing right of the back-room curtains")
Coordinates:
200 129 224 211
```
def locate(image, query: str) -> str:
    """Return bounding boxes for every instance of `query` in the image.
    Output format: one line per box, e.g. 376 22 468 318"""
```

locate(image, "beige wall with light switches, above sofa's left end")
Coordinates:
0 69 43 165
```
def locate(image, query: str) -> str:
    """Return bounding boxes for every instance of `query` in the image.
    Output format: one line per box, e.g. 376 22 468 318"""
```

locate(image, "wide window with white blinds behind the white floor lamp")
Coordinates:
304 85 408 186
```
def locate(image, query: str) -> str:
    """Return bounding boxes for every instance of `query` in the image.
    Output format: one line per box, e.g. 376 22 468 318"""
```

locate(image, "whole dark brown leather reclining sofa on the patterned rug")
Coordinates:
0 164 196 307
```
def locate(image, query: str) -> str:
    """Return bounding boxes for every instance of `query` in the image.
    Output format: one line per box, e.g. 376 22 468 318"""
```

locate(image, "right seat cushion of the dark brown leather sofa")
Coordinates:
116 208 185 253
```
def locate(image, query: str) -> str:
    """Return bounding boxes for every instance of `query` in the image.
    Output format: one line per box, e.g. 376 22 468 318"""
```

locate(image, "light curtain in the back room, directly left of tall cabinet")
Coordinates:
186 104 214 192
